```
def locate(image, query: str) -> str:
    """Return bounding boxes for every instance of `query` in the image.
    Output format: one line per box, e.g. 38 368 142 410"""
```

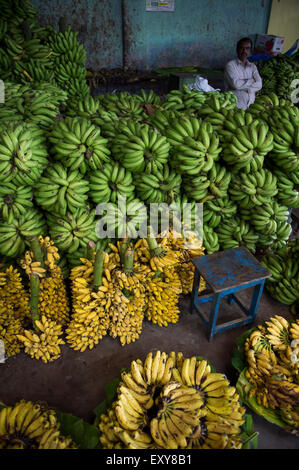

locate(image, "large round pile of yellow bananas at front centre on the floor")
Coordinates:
99 351 245 449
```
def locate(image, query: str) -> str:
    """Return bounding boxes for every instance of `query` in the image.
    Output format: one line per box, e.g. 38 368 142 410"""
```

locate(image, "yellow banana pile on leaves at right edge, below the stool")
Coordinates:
245 315 299 428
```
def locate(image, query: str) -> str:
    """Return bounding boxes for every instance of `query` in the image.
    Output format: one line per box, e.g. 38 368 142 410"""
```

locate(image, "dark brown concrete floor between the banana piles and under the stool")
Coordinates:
0 289 299 449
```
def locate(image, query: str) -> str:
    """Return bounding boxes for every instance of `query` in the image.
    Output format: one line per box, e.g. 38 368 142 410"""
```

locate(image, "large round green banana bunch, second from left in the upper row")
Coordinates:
49 117 110 175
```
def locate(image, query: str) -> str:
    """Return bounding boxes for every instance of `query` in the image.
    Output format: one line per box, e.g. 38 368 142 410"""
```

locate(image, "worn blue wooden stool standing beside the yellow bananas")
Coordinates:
191 247 271 341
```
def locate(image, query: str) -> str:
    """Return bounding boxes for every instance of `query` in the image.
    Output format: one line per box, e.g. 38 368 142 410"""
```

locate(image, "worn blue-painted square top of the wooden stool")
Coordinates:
192 247 271 292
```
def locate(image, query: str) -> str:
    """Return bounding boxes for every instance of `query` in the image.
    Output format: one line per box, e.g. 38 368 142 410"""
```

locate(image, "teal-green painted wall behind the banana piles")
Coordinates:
33 0 271 69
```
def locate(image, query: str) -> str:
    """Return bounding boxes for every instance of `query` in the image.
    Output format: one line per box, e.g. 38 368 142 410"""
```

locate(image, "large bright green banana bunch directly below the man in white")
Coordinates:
222 120 273 173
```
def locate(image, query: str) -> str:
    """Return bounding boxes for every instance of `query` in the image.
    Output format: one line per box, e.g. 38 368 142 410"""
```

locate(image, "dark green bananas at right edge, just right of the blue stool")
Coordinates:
261 238 299 315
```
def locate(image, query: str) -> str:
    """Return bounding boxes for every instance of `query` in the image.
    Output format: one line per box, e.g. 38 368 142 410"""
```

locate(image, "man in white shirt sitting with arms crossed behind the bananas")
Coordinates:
224 38 262 109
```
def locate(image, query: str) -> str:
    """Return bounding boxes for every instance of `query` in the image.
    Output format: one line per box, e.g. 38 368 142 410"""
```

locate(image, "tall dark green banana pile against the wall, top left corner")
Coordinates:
0 0 89 97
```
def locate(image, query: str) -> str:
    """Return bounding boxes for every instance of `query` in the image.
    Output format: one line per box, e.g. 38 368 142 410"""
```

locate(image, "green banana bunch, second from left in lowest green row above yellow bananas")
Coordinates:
46 206 98 254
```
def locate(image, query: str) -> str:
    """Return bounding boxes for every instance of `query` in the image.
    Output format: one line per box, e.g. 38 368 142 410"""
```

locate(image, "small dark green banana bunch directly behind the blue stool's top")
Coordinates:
215 216 258 253
